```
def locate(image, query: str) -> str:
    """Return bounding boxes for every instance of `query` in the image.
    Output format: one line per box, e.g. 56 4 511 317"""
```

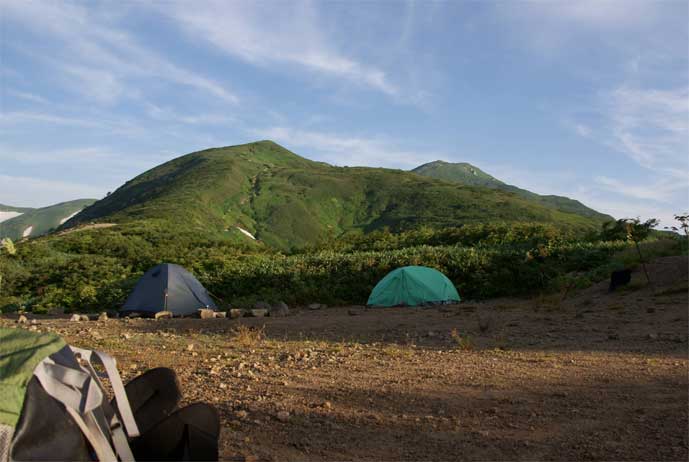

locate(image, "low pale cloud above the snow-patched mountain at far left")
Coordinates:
0 174 106 207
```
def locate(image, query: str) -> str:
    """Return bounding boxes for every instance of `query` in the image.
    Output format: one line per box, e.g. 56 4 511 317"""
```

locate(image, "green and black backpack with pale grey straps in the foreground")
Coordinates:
0 328 220 462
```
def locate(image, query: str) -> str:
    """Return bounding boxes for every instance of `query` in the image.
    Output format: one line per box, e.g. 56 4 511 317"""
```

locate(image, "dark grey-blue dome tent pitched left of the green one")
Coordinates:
120 263 216 316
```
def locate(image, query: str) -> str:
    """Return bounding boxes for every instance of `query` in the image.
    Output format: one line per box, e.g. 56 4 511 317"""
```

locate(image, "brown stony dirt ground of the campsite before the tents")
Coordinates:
0 257 689 461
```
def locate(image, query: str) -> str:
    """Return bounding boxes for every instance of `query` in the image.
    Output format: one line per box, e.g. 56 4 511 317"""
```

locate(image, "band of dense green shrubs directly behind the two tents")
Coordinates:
0 217 677 312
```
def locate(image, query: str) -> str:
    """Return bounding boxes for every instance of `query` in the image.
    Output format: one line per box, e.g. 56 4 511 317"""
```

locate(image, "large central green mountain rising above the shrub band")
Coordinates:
62 141 599 249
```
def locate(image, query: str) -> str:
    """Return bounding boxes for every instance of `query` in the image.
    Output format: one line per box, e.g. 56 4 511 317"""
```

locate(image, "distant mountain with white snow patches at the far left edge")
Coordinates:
0 199 96 240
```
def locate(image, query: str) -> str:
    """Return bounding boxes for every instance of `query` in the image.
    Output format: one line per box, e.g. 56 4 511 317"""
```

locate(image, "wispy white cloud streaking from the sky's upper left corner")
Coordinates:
2 0 238 104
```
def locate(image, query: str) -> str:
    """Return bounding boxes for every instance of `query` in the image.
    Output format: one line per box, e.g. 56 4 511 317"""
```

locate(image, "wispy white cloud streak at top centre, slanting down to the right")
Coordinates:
159 1 399 96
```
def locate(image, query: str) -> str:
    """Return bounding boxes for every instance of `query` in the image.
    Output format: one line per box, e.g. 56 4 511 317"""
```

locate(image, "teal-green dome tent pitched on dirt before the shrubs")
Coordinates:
367 266 460 306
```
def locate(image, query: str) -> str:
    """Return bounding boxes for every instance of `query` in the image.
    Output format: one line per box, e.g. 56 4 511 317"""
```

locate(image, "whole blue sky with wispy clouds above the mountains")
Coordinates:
0 0 689 224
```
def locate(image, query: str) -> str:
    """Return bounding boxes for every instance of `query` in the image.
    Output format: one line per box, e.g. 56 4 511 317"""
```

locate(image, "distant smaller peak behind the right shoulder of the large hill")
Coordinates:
412 160 613 221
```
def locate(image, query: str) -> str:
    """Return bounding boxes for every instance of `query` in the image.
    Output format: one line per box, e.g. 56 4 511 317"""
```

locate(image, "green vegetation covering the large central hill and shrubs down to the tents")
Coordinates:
0 141 686 312
